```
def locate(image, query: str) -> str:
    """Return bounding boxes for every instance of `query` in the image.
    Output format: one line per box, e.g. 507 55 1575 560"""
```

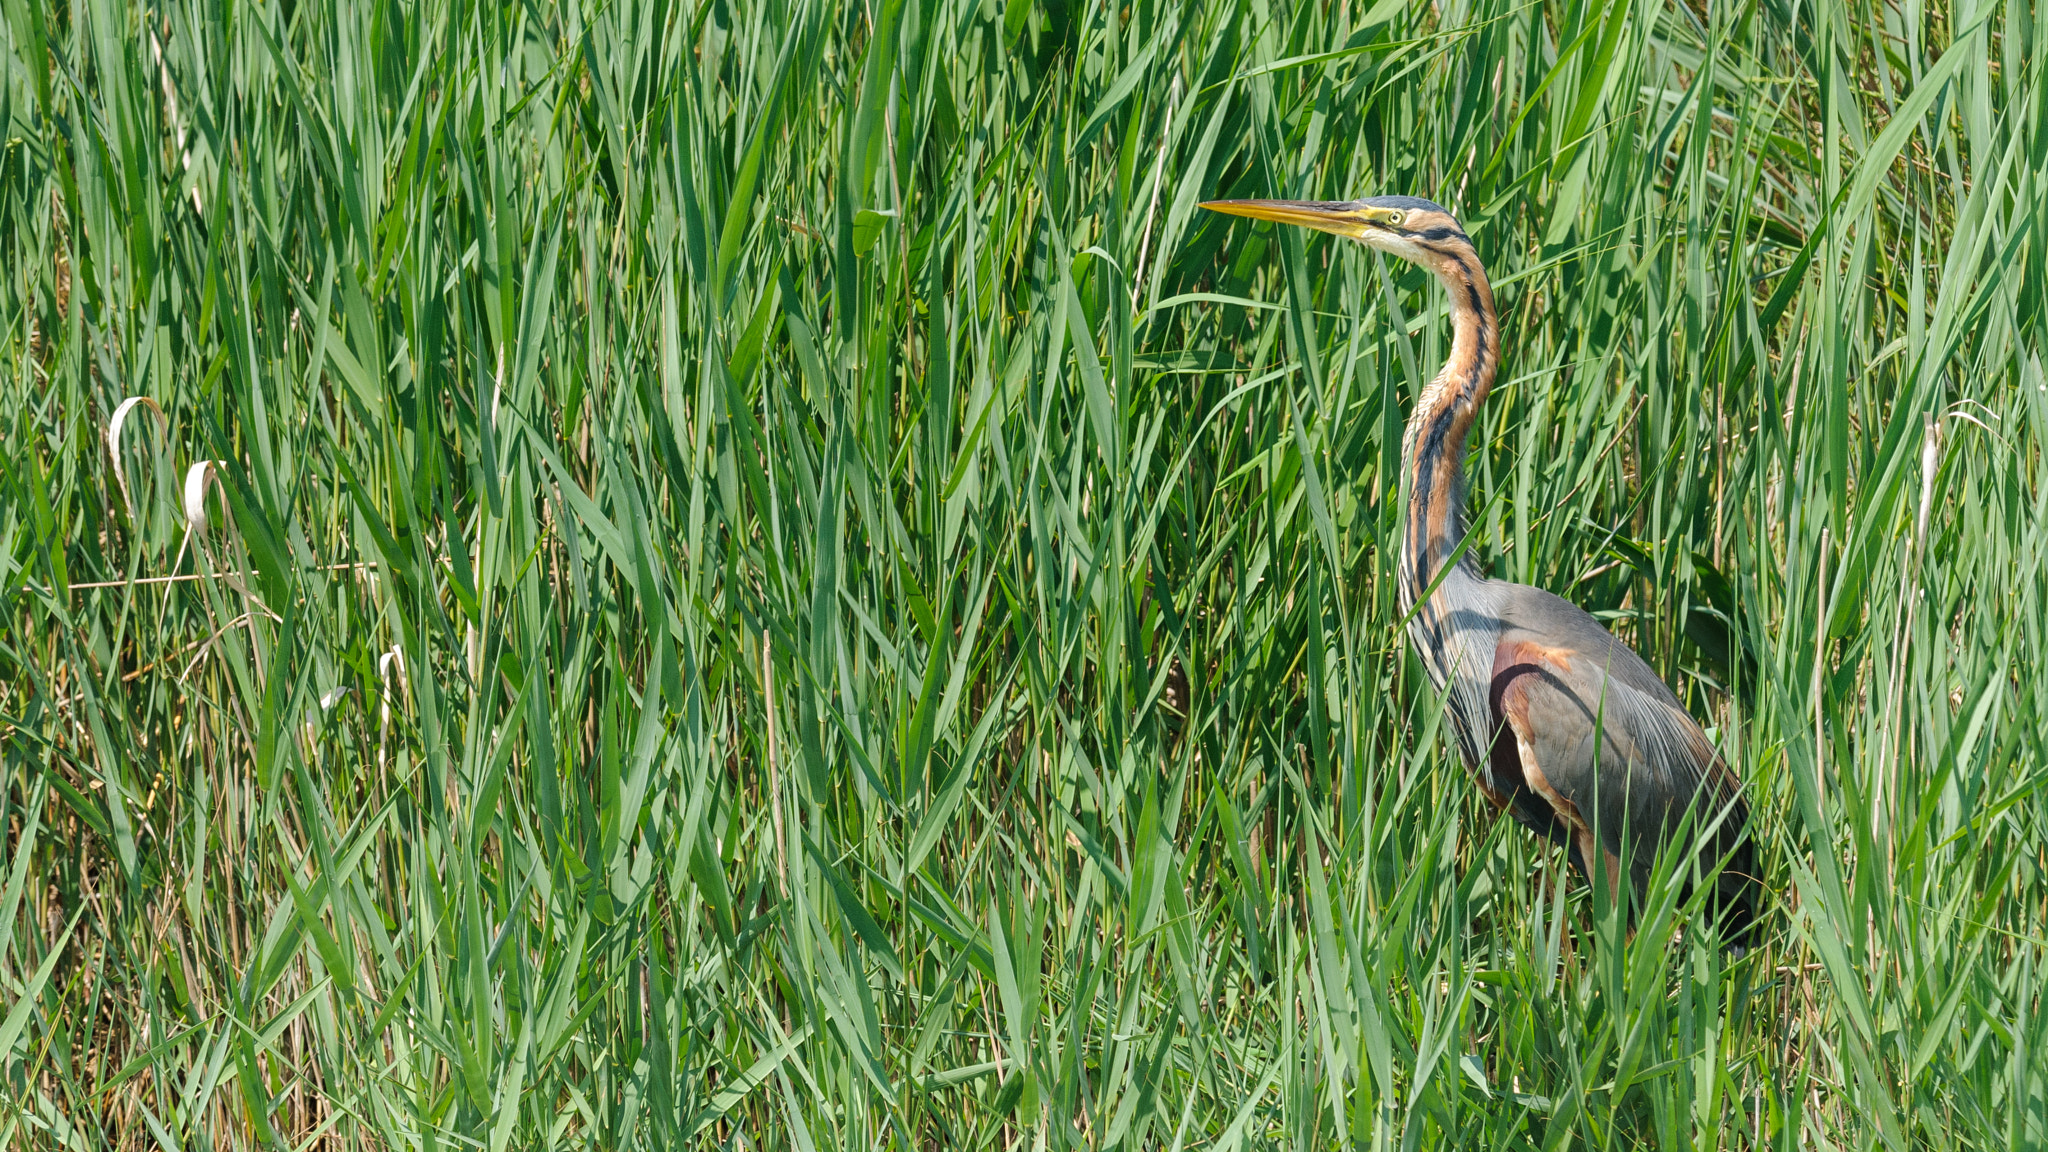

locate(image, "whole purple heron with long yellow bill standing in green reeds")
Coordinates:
1204 197 1757 941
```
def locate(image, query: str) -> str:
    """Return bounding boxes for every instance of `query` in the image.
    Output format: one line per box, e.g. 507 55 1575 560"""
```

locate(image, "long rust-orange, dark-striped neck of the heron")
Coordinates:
1401 256 1501 611
